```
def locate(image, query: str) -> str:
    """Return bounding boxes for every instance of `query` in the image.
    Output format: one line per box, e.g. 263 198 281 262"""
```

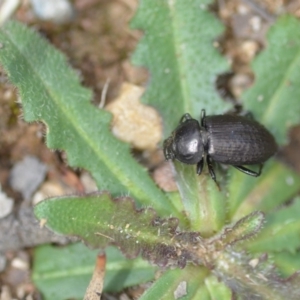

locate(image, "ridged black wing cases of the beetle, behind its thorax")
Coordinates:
203 115 277 165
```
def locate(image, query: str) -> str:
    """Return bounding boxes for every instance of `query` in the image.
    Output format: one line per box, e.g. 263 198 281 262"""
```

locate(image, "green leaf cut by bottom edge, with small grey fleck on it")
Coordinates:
140 266 210 300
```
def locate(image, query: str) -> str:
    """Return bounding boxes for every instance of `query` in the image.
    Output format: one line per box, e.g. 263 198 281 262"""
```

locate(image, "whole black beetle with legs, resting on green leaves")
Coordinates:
164 109 277 181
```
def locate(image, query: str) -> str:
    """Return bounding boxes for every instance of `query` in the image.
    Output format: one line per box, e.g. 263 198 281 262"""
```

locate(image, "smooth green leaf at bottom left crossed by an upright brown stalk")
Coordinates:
32 243 155 300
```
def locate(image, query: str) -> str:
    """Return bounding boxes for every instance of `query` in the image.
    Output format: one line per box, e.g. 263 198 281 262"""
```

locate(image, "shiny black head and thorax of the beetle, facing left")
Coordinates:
164 119 204 164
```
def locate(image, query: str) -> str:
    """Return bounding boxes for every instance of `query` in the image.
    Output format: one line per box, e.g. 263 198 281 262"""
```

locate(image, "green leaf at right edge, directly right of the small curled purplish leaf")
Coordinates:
245 198 300 253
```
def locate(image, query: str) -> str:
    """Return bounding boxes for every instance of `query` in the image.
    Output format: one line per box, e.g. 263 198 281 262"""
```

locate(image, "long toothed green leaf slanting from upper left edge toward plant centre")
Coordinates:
0 22 180 217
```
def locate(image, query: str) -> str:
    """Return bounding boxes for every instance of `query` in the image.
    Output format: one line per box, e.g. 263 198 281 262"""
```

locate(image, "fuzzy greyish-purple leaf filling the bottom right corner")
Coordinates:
213 248 300 300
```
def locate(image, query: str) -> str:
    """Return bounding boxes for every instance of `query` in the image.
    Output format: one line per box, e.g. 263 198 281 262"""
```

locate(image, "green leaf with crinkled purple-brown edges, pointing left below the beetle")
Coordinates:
35 193 200 267
